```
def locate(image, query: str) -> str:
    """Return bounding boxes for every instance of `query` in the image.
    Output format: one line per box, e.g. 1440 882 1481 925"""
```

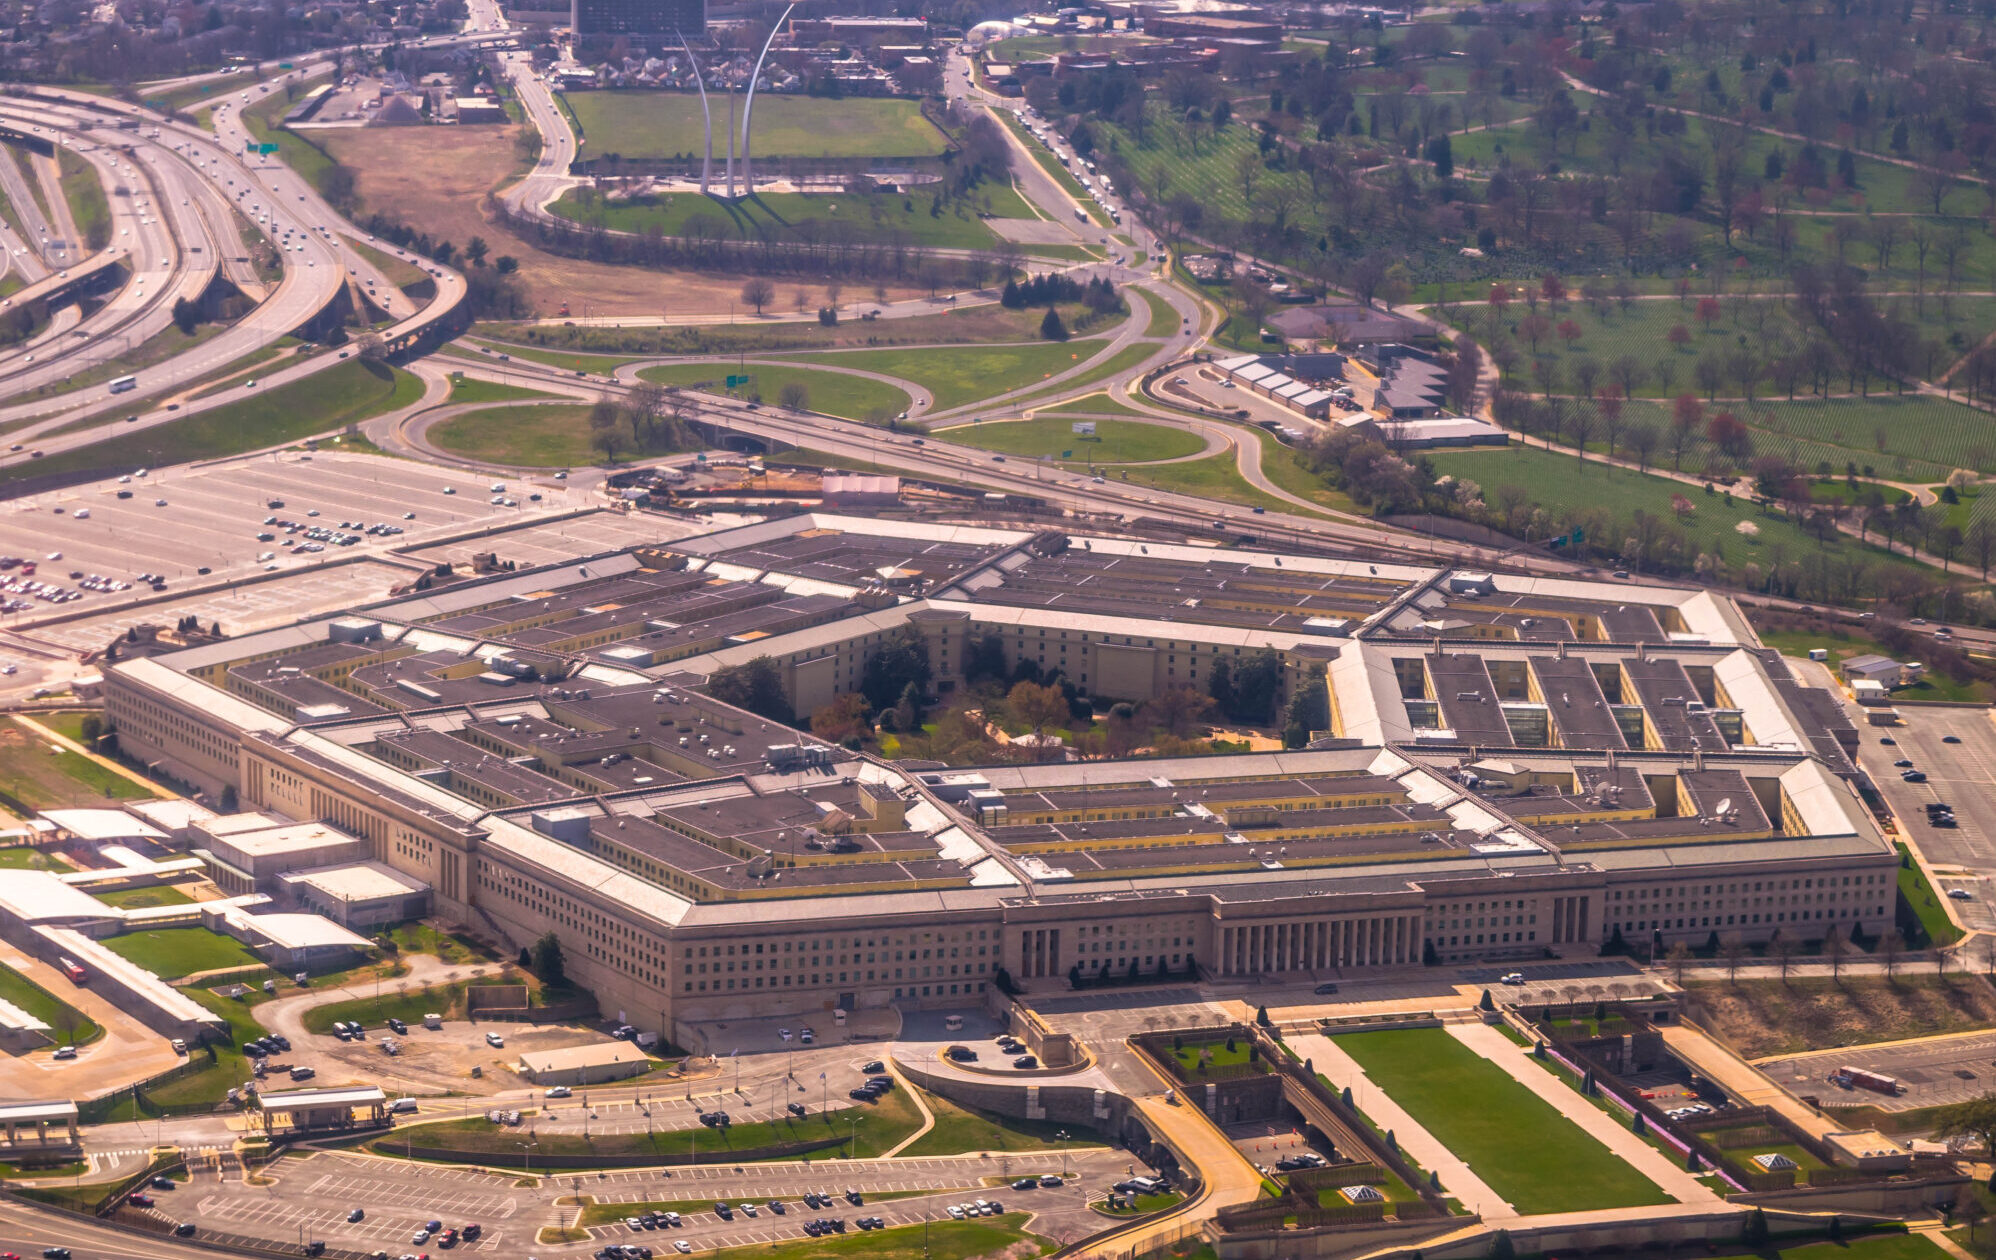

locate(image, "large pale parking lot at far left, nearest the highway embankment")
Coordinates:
0 451 591 619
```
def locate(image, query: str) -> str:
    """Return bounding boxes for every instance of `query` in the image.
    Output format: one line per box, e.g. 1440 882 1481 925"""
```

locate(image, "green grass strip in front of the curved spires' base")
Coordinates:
549 184 1032 250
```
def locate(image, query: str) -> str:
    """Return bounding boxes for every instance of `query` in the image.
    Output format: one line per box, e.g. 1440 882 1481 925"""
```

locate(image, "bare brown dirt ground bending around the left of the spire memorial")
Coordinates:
313 126 926 317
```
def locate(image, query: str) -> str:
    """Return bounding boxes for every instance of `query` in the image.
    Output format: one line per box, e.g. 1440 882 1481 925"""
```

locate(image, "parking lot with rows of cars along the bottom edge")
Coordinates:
187 1148 1148 1256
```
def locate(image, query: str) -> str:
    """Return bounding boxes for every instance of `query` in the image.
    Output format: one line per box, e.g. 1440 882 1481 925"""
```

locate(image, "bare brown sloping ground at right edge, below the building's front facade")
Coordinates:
1685 974 1996 1058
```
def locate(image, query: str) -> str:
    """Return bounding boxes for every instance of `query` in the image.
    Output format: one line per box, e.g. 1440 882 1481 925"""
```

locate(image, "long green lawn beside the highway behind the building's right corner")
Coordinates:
1429 443 1906 583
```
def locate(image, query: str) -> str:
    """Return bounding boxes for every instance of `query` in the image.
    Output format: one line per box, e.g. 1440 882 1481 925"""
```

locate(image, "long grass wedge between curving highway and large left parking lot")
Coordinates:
0 359 423 491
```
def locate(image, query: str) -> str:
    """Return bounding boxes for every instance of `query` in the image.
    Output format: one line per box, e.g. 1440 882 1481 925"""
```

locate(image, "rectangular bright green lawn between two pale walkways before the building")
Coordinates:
1337 1028 1671 1216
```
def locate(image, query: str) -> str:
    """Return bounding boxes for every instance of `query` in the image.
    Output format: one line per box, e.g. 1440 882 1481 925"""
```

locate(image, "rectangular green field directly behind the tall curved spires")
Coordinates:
563 92 944 161
